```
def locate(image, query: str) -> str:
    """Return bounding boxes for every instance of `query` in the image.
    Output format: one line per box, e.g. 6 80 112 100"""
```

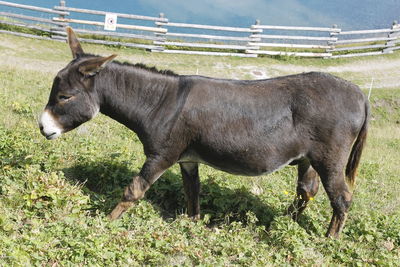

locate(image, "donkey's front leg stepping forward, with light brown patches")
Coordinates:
108 158 172 220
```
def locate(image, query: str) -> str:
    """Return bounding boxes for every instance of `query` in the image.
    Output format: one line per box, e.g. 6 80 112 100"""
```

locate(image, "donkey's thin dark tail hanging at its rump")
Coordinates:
346 100 370 188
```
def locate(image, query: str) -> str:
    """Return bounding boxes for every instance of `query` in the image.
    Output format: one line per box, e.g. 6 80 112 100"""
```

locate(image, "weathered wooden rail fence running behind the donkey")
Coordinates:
0 0 400 58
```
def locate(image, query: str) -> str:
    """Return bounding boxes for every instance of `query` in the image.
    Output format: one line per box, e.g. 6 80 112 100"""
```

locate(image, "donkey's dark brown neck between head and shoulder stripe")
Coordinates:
96 63 179 139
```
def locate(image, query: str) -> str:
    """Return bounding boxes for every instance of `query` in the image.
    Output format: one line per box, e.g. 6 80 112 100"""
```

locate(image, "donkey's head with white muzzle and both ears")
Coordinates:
39 27 116 139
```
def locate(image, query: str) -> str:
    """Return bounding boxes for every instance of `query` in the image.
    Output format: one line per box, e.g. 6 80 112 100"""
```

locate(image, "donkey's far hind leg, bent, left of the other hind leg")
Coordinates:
288 159 319 221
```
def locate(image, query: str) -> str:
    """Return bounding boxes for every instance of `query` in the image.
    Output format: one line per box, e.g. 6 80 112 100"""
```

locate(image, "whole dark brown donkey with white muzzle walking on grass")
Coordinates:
39 27 370 238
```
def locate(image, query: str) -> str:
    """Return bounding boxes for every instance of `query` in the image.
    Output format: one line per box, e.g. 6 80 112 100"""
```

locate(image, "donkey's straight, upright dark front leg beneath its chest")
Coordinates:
179 163 200 219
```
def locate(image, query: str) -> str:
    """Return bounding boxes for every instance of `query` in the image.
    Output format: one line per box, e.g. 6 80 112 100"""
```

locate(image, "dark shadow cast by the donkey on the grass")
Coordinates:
63 160 312 231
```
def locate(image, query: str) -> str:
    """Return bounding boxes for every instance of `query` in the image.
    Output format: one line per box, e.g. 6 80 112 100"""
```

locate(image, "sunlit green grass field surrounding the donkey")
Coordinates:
0 35 400 266
